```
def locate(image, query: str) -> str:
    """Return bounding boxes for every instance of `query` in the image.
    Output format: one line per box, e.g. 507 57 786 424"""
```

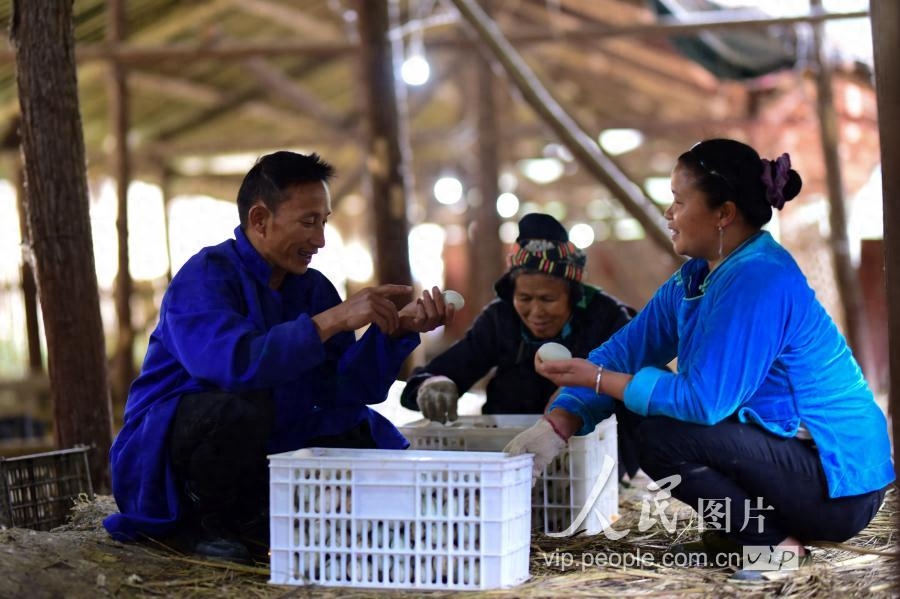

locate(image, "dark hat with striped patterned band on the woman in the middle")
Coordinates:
494 213 587 299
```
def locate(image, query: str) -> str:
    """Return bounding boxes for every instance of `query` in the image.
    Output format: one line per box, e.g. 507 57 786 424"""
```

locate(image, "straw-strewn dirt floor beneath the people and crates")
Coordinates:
0 485 900 599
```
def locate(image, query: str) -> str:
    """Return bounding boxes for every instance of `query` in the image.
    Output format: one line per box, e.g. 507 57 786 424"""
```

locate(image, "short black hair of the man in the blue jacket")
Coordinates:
237 150 334 229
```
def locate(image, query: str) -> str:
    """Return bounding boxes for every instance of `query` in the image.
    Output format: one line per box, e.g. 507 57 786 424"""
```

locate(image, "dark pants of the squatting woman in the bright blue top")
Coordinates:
616 409 885 546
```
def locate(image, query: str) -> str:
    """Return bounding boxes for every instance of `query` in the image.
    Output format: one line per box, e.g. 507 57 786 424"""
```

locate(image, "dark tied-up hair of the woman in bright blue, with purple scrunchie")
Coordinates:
678 139 803 227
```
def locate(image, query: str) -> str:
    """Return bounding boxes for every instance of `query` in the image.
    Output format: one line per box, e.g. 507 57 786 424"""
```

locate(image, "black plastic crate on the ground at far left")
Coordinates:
0 447 94 530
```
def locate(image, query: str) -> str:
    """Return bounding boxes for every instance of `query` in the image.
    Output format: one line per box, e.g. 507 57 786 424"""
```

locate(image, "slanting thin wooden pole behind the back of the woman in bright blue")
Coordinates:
812 0 869 368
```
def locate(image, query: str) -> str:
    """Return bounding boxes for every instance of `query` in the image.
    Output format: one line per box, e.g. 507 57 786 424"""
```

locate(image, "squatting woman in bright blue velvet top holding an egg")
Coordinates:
508 139 894 555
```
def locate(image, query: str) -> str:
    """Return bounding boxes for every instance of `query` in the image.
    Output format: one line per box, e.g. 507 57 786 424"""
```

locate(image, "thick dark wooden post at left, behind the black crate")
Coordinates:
10 0 112 492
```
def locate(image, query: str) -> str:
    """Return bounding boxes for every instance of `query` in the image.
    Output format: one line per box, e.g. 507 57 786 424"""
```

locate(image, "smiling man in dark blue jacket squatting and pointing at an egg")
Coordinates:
104 152 453 560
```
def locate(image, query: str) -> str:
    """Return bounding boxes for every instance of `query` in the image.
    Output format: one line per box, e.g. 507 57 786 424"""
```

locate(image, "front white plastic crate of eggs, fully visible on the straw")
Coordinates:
269 448 532 590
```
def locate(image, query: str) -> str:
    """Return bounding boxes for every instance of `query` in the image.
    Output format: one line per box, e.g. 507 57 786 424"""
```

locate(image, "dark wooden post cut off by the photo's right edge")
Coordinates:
870 0 900 478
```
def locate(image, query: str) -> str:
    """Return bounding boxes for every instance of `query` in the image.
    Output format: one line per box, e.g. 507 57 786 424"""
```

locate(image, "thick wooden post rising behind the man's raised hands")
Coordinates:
357 0 412 284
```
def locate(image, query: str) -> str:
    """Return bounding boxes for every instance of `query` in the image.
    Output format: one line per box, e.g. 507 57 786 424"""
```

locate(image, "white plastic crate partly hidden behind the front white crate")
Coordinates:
399 414 619 535
